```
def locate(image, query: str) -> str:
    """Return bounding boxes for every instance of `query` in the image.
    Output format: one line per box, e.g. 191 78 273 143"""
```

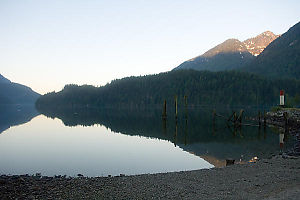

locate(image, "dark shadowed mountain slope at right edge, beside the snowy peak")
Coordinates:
242 22 300 79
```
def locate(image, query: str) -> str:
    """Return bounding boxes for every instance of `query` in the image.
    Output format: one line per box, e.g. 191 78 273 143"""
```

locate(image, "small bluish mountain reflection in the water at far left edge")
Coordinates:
0 105 39 133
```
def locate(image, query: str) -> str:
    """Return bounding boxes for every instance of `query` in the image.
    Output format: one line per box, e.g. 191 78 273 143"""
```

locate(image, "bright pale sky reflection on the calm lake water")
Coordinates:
0 113 212 176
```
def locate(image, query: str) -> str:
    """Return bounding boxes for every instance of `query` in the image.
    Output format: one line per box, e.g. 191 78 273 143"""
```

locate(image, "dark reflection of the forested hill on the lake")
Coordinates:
37 106 288 164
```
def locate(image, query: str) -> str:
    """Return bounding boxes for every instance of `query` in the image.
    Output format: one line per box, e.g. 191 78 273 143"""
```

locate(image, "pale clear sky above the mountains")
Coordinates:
0 0 300 94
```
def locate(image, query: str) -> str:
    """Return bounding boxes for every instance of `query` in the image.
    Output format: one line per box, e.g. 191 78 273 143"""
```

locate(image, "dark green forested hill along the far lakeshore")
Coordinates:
36 70 300 108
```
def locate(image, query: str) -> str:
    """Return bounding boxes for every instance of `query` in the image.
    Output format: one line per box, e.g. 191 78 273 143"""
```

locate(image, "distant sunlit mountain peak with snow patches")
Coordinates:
175 31 278 71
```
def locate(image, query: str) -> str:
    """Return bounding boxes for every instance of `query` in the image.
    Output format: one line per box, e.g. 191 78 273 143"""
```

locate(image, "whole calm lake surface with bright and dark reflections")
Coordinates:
0 105 292 176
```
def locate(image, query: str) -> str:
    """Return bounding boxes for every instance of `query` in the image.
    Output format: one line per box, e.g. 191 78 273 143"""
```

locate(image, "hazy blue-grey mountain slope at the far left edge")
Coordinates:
0 74 40 104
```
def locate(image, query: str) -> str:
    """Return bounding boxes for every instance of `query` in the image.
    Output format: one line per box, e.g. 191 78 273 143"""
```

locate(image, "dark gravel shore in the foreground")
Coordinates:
0 156 300 199
